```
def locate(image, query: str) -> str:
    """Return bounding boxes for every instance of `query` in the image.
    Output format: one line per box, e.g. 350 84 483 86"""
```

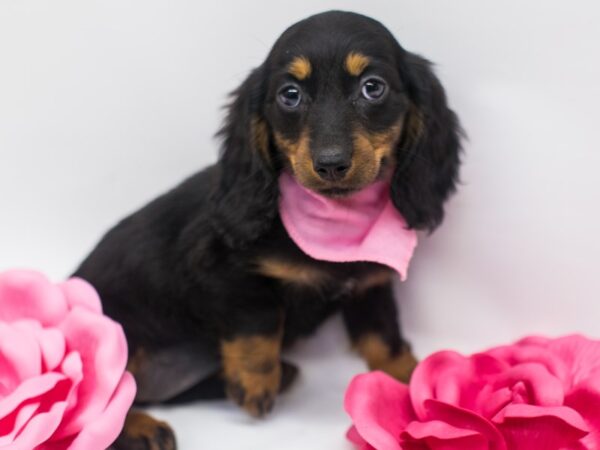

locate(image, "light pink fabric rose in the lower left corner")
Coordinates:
0 270 135 450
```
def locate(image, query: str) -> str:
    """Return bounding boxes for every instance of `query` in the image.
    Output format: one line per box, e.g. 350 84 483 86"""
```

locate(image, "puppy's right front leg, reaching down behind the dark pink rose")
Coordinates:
343 282 417 383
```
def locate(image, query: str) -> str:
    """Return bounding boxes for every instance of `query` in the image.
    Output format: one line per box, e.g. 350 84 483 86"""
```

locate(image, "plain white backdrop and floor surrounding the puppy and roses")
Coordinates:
0 0 600 450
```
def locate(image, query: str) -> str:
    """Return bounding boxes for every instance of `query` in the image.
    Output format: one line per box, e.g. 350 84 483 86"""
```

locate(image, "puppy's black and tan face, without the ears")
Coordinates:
264 13 409 196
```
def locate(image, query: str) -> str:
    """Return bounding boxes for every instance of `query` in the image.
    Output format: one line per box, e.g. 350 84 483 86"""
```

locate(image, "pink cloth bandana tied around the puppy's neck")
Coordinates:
279 172 417 280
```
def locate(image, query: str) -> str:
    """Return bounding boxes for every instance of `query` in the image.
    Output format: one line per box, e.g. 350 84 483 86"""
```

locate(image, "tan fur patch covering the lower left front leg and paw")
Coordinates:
221 335 281 416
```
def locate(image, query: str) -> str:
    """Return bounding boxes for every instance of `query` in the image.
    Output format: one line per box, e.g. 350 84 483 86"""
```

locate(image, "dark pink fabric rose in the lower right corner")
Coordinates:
345 335 600 450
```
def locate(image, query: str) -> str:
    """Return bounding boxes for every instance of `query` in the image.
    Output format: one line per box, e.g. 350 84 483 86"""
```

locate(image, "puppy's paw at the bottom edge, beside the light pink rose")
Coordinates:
109 411 177 450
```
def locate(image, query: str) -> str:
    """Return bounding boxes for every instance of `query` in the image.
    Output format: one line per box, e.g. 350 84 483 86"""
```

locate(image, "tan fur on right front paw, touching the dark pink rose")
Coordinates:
356 333 417 383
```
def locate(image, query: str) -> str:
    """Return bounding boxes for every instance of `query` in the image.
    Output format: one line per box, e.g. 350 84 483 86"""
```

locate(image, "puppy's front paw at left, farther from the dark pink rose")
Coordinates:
226 363 281 417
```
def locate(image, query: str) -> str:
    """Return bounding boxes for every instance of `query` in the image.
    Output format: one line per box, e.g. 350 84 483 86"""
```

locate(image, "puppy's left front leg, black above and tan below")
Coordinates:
221 311 282 417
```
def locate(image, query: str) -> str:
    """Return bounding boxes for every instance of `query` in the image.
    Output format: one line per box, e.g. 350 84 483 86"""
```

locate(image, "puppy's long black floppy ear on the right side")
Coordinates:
391 52 461 232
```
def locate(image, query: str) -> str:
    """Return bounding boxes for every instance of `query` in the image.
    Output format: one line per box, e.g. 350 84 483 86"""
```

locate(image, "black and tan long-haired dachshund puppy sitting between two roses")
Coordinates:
75 11 460 449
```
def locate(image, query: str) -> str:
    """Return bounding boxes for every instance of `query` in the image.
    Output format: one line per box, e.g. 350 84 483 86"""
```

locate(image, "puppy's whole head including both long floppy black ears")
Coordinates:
213 11 460 246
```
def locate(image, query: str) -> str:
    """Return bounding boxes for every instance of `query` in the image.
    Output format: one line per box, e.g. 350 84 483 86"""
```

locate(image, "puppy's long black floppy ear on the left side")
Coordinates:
210 67 278 247
